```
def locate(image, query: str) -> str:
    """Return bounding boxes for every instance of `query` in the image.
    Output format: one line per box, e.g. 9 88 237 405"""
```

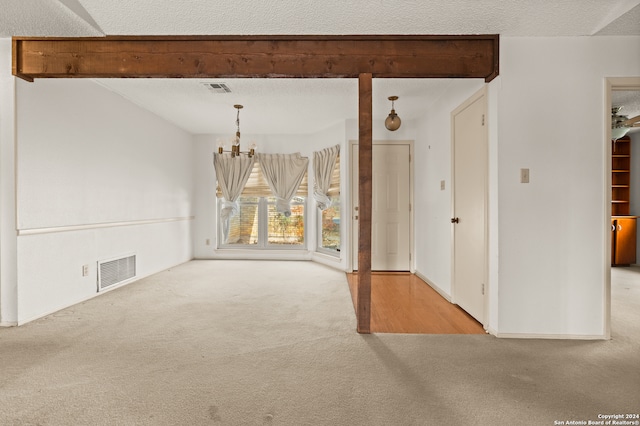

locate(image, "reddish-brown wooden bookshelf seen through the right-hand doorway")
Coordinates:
611 136 631 216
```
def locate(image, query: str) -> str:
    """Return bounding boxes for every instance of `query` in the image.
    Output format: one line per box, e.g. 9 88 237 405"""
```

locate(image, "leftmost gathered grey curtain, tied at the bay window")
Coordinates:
213 152 256 242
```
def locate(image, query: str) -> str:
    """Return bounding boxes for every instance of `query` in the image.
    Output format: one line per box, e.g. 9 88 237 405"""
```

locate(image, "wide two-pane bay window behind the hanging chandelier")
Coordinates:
217 162 307 250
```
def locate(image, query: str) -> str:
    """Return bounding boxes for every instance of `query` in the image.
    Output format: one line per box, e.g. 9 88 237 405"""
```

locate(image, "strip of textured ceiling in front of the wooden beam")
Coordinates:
0 0 640 36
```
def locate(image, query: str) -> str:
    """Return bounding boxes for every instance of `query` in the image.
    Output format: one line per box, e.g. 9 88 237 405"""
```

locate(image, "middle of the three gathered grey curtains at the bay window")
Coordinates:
256 152 309 217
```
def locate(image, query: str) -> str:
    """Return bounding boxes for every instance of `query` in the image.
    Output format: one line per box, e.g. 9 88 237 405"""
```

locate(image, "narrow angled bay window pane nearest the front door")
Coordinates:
318 155 340 256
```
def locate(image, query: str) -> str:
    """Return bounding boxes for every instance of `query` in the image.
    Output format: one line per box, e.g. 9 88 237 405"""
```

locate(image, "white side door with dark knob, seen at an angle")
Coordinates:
452 92 487 322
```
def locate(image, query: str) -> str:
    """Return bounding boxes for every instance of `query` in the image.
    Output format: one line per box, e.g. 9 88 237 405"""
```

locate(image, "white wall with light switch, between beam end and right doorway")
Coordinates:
497 37 640 337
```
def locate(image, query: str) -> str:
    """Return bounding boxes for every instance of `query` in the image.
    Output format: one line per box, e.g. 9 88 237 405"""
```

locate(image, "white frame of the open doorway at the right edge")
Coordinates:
602 77 640 340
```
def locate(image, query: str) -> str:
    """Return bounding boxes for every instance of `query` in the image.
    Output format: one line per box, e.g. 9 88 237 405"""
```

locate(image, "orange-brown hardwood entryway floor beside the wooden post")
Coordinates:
347 272 485 334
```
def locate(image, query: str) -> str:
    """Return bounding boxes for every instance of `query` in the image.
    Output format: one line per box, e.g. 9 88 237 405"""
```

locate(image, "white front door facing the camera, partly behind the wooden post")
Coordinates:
351 143 411 271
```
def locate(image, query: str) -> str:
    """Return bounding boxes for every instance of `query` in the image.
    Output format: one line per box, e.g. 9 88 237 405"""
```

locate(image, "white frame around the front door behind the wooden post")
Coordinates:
345 139 416 274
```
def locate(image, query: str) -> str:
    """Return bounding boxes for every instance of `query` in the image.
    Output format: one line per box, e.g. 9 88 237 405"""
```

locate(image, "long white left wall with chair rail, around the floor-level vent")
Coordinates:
16 79 193 323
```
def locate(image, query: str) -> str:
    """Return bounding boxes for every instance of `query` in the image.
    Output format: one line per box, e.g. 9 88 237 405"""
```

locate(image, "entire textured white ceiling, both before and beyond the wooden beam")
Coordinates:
0 0 640 133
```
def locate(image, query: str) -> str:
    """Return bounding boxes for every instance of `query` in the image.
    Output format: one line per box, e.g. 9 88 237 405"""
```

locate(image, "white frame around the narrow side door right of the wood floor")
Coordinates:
450 85 491 330
